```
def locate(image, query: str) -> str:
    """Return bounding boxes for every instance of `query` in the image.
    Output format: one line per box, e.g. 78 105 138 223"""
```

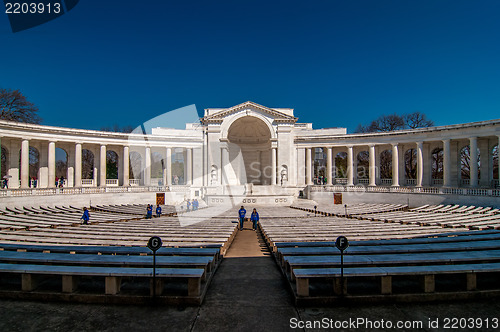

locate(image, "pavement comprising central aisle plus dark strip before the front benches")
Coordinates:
0 223 500 332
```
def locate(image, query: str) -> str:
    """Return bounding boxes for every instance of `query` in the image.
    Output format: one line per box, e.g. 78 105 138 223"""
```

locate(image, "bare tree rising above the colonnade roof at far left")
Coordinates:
0 89 42 123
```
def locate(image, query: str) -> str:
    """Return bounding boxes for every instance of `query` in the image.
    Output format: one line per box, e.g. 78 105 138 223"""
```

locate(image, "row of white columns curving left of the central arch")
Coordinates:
0 138 193 188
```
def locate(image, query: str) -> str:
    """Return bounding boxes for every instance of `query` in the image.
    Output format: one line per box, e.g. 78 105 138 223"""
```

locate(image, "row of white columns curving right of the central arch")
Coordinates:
297 136 500 188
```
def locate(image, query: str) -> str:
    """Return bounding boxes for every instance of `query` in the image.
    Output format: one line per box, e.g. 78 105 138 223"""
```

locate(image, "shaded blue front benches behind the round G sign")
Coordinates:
0 244 220 304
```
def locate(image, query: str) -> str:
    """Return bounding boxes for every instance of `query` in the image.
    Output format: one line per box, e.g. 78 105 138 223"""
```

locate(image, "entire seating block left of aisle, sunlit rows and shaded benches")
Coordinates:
0 206 237 304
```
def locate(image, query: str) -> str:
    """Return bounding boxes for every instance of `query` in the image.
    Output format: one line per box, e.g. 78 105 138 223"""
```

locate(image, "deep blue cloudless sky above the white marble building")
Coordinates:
0 0 500 132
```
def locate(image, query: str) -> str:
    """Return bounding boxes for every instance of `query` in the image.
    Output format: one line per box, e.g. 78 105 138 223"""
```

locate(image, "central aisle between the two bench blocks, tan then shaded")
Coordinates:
193 222 298 331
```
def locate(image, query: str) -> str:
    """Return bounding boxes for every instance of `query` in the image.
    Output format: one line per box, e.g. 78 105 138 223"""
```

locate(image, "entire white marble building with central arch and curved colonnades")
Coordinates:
0 102 500 206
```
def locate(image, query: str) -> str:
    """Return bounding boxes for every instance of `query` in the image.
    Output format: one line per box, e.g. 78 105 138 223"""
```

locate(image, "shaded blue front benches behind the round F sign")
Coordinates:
260 222 500 304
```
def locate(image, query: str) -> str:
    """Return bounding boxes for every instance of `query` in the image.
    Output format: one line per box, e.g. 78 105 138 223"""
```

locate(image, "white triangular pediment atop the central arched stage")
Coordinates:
201 101 298 124
